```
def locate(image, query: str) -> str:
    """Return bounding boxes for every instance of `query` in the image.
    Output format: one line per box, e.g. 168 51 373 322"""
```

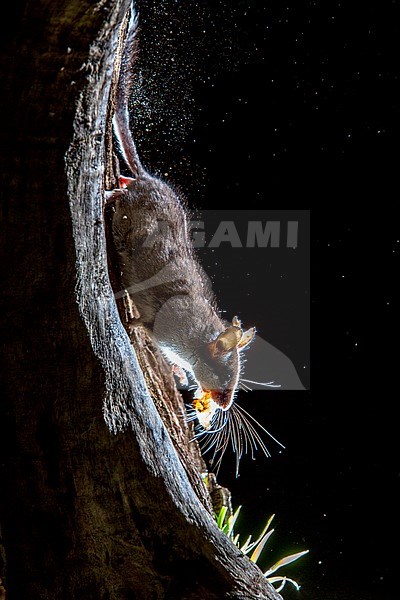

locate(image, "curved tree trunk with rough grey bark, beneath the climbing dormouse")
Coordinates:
0 0 280 600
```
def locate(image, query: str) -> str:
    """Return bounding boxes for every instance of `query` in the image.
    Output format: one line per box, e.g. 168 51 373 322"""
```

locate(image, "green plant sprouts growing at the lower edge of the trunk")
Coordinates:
216 506 309 592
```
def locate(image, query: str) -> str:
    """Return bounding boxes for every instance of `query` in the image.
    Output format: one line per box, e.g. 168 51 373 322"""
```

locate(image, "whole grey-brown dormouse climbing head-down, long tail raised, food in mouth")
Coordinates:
107 10 255 429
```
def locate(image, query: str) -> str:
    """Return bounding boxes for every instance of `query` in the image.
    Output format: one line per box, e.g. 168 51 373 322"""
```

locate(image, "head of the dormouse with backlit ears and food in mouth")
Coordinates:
193 317 256 429
